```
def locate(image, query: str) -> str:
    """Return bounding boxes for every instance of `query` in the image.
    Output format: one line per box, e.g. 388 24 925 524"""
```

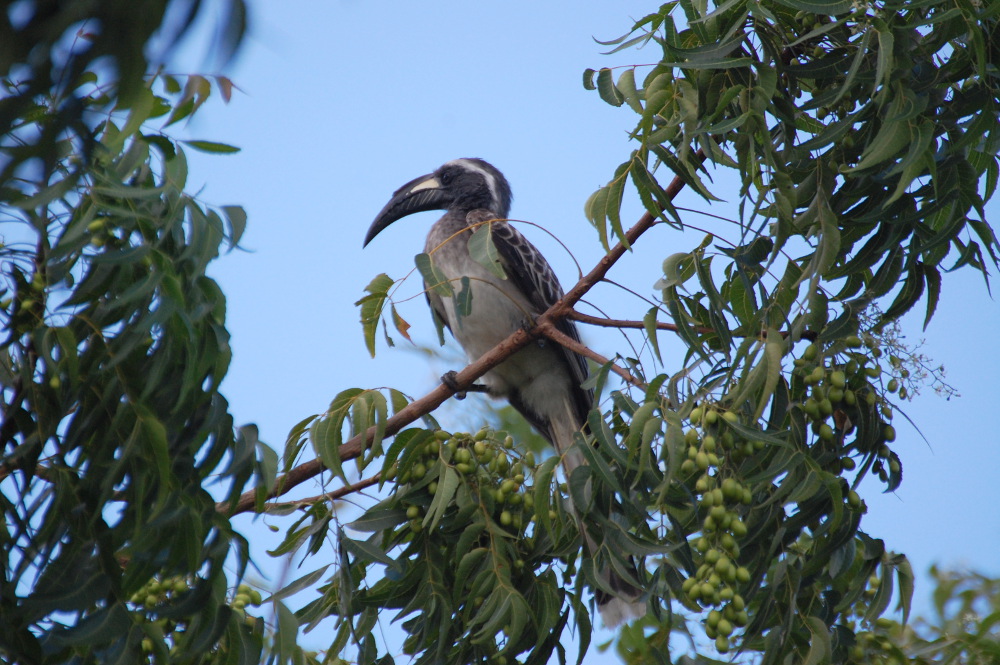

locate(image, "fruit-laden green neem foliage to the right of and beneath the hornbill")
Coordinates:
240 0 1000 664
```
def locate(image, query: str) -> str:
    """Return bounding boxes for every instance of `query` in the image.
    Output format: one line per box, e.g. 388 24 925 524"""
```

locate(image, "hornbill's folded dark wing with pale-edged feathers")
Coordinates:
476 210 594 425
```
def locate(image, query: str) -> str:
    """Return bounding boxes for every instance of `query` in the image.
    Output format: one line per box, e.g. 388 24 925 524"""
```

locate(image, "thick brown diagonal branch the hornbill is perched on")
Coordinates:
215 158 705 515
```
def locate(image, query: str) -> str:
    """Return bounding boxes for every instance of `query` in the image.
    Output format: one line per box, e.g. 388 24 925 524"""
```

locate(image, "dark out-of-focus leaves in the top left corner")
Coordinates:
0 0 247 181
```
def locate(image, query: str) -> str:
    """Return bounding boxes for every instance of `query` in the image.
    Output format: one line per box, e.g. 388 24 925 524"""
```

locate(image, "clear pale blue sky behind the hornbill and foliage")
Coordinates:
171 0 1000 652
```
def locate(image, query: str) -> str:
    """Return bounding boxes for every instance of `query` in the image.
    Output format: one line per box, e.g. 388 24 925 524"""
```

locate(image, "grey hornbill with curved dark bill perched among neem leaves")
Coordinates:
363 158 646 627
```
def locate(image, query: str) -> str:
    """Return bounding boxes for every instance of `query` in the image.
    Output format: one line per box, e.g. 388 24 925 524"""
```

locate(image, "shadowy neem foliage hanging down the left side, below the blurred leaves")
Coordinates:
0 73 263 663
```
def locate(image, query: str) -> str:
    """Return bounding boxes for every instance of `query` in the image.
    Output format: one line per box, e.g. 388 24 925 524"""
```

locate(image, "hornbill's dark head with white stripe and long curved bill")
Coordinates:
364 158 512 246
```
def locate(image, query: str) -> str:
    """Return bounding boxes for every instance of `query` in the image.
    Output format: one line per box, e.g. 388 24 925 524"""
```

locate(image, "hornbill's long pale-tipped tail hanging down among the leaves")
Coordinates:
550 409 646 628
